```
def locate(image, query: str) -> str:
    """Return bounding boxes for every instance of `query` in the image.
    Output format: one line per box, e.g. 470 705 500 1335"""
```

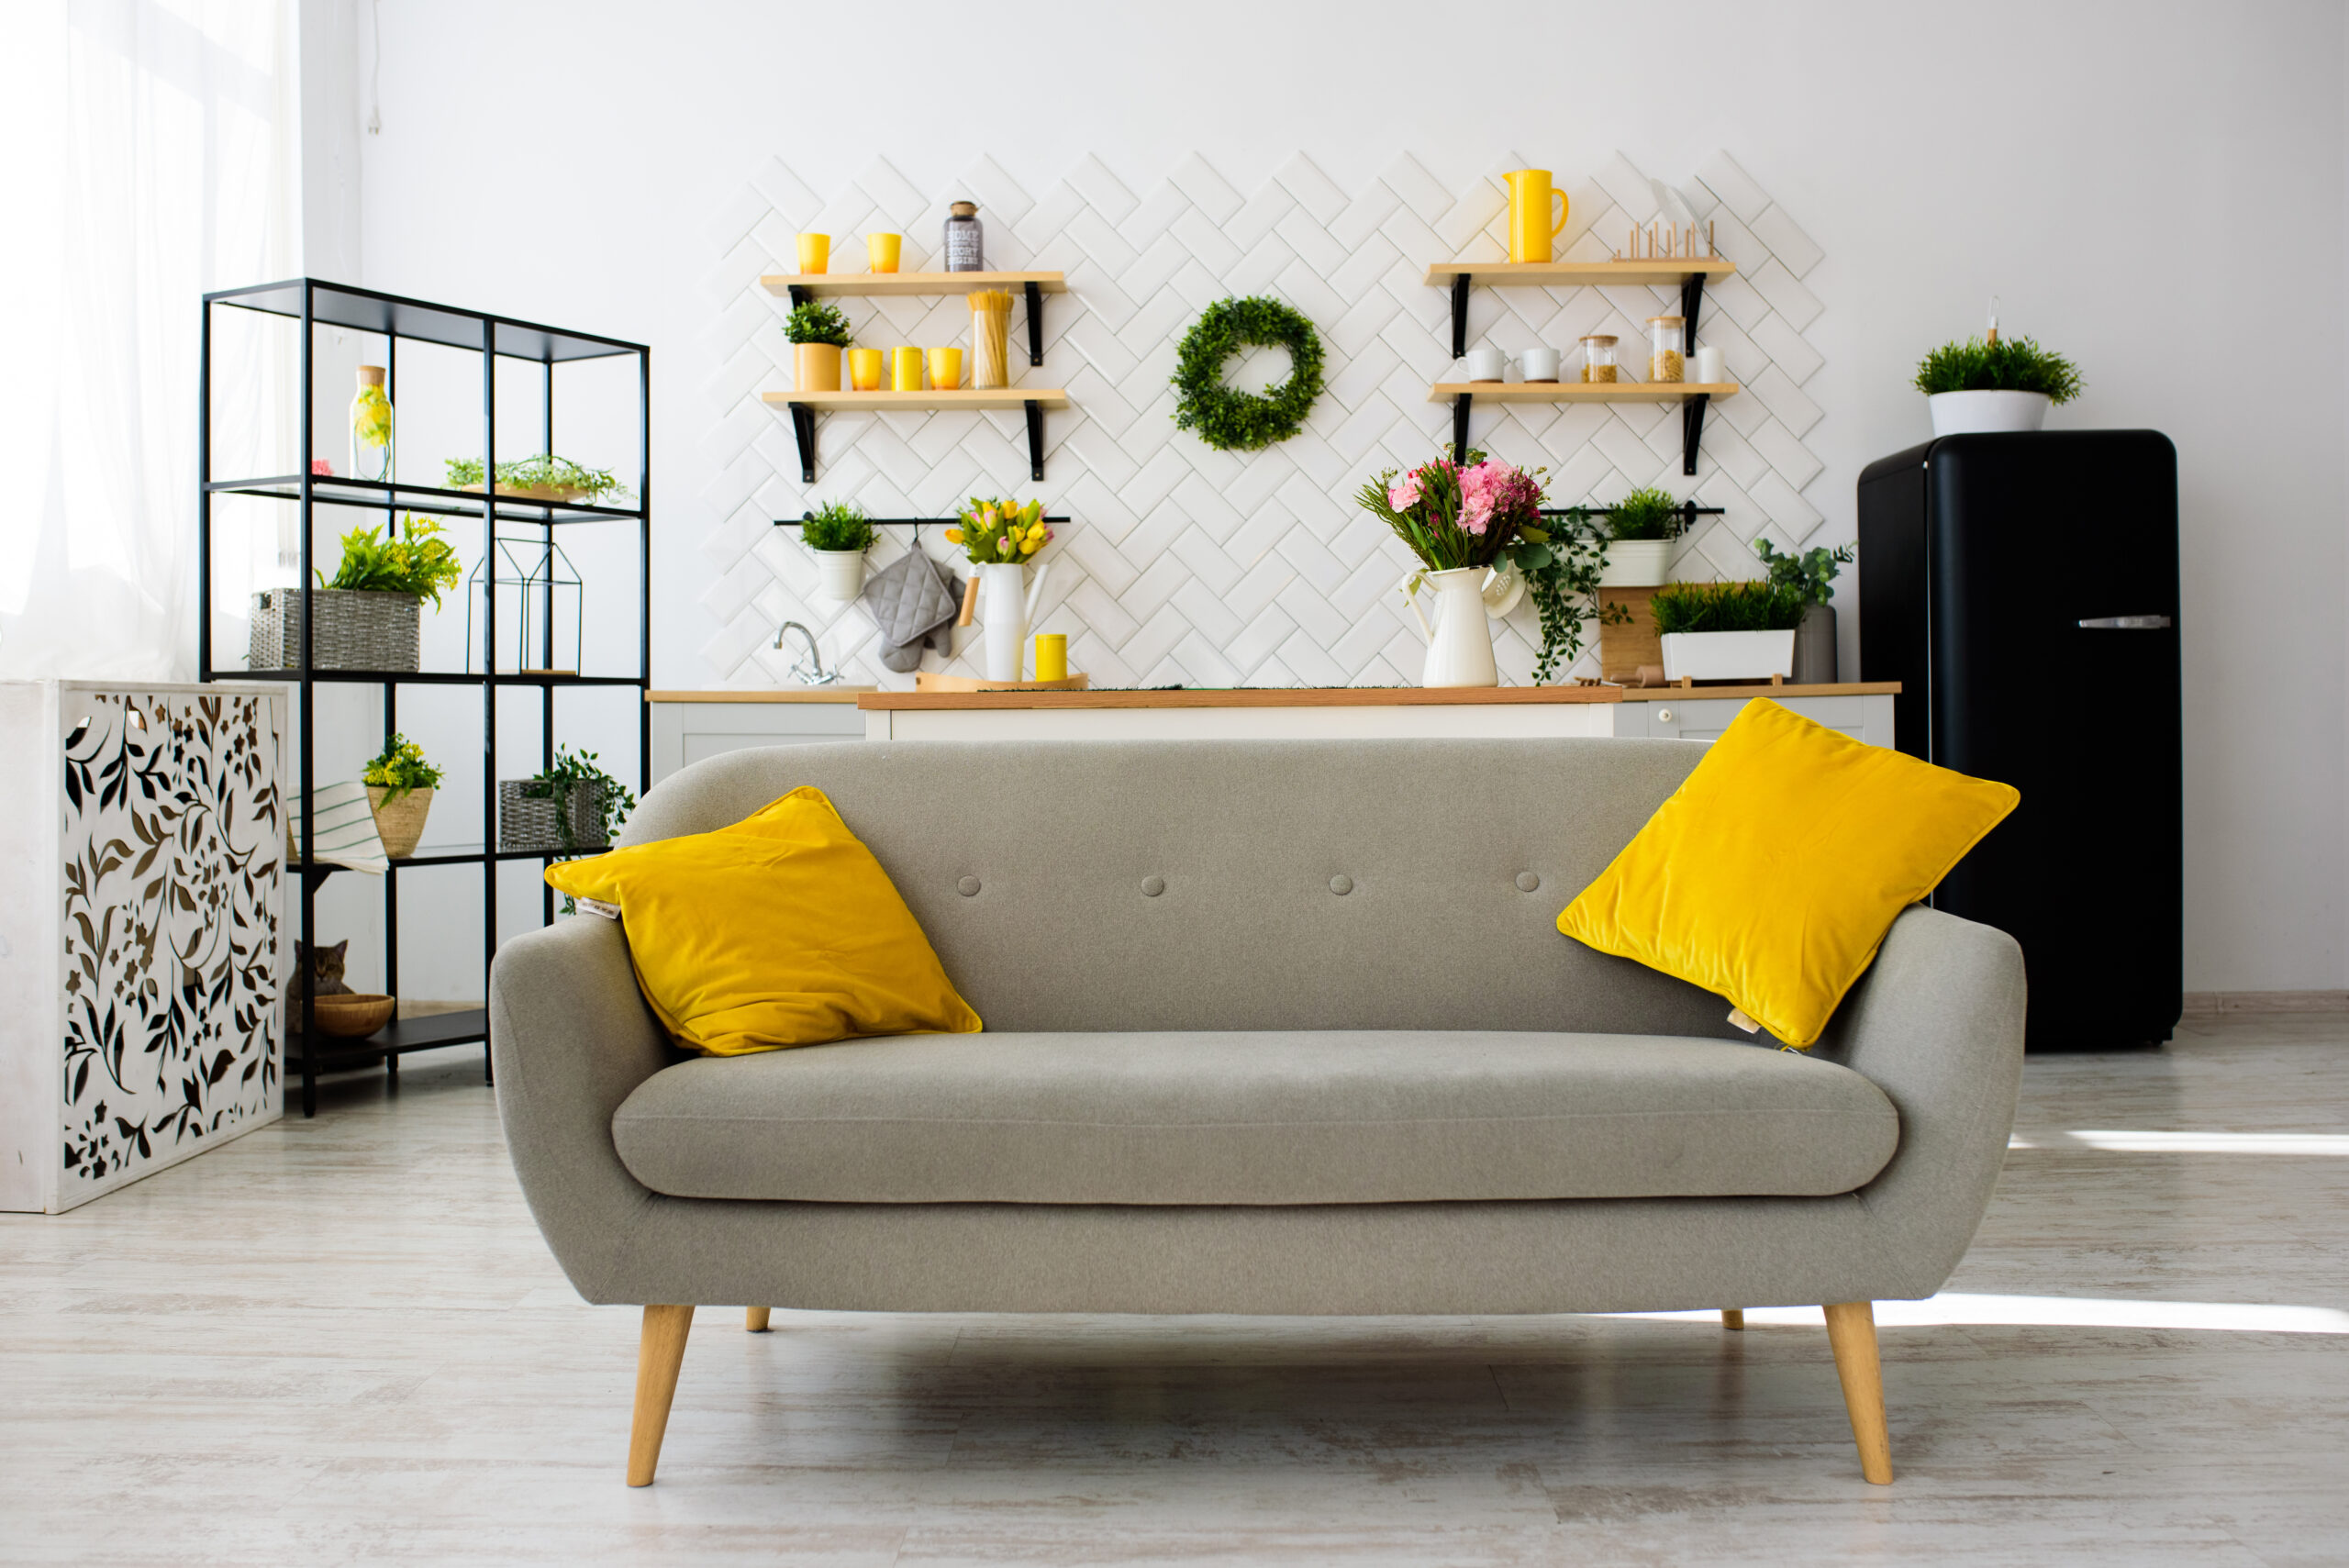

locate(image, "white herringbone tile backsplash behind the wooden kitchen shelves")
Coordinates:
702 152 1823 685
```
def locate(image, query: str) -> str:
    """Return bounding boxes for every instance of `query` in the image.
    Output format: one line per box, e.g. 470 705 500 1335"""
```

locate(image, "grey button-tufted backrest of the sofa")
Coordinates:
622 740 1741 1038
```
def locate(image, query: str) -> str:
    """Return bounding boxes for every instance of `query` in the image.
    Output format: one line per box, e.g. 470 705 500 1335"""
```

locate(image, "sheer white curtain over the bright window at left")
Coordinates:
0 0 301 681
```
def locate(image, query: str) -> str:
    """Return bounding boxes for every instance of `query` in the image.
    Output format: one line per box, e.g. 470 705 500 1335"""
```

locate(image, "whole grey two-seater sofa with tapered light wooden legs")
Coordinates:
488 740 2022 1485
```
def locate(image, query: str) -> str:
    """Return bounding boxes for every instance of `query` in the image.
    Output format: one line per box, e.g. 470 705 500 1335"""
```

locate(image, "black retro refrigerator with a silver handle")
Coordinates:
1861 429 2185 1051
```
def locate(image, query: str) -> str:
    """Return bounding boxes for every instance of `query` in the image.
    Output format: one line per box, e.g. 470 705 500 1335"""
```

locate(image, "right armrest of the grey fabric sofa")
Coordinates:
1818 904 2025 1296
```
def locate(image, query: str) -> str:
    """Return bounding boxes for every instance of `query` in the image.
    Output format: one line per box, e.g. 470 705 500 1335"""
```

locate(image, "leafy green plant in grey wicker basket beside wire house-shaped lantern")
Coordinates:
244 517 465 672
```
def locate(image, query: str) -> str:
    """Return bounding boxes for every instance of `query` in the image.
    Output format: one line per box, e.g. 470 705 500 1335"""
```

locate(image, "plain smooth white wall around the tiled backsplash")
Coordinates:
326 0 2349 991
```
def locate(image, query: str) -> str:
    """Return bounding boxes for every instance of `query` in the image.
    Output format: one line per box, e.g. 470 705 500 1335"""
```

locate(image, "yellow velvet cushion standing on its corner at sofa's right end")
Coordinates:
1557 697 2022 1050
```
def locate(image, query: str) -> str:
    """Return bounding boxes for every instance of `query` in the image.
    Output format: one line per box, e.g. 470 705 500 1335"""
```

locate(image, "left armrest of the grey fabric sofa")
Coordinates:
488 916 672 1300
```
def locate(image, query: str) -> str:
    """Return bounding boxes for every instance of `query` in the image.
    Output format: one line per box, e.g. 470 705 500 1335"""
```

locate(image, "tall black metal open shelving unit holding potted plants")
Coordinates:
197 277 653 1115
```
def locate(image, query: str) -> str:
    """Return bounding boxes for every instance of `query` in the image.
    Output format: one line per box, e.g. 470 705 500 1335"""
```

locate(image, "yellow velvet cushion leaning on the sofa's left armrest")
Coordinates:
547 786 980 1056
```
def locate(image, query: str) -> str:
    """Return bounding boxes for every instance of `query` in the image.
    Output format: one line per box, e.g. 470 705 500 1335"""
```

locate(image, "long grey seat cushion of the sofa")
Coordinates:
611 1030 1900 1204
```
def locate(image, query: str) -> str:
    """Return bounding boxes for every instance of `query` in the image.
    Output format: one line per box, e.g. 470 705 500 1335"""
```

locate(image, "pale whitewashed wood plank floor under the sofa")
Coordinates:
0 1017 2349 1568
